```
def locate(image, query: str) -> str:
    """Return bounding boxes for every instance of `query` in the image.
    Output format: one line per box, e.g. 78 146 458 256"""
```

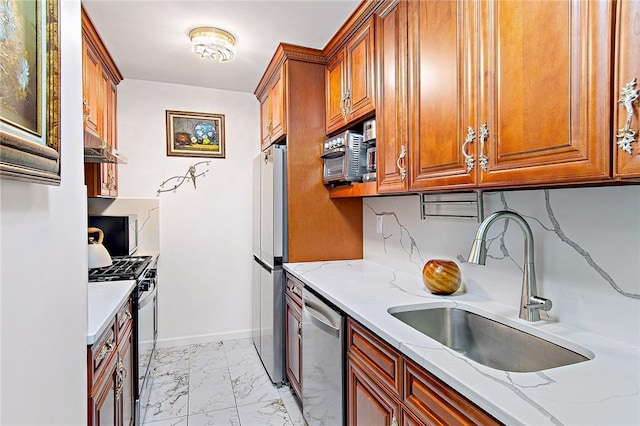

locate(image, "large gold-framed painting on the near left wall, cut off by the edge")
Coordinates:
0 0 60 185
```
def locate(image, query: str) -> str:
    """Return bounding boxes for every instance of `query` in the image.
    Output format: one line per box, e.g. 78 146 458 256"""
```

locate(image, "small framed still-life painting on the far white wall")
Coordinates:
167 110 224 158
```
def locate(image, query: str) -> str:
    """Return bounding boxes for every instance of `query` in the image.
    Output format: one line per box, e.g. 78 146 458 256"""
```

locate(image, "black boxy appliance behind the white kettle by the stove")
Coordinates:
89 214 138 256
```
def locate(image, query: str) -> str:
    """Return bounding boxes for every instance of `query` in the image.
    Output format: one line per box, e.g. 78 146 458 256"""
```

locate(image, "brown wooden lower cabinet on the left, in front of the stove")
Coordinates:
87 299 135 426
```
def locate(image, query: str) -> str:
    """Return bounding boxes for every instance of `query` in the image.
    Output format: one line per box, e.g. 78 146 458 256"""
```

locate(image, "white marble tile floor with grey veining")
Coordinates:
143 338 305 426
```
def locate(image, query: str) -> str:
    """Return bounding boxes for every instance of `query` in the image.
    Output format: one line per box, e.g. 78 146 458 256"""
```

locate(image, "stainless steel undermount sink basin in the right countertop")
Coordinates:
389 307 590 373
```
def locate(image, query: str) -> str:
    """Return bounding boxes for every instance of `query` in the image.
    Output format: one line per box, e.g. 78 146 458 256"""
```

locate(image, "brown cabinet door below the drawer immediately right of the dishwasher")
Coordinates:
347 357 400 426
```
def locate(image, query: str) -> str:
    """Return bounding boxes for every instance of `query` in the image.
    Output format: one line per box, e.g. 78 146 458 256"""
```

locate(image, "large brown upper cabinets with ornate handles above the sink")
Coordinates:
376 0 639 193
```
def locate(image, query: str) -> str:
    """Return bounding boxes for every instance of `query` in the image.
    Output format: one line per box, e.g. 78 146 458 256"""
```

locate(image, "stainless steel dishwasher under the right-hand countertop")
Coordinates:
302 288 345 426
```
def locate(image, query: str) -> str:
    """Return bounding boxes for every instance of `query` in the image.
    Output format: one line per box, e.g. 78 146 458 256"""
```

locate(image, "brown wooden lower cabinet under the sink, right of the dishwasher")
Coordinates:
347 318 501 426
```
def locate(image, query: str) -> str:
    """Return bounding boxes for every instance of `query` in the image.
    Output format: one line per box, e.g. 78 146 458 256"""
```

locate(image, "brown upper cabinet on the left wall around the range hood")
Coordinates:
82 9 122 198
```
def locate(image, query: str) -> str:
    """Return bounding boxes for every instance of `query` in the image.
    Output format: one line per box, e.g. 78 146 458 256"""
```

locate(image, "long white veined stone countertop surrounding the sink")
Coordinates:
284 260 640 425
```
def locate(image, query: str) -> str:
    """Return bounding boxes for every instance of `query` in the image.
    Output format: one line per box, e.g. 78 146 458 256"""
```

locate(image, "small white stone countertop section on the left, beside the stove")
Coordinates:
87 280 136 345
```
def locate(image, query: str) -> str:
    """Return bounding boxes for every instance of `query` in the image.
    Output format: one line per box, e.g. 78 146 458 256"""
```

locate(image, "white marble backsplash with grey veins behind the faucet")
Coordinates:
363 186 640 346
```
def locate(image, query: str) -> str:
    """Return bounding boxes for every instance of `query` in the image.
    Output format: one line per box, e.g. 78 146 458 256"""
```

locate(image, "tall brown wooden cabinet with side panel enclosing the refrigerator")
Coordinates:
254 43 362 262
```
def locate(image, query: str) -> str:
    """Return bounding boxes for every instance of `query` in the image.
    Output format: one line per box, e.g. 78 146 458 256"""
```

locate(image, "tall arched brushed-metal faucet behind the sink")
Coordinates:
468 210 552 322
